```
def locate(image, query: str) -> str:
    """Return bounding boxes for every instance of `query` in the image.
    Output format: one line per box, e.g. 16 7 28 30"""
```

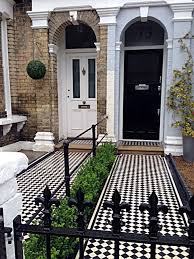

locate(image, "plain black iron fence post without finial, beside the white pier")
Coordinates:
13 215 23 259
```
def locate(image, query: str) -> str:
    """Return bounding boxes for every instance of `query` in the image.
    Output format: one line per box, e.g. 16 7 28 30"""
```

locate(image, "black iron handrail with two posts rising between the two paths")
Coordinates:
63 116 108 197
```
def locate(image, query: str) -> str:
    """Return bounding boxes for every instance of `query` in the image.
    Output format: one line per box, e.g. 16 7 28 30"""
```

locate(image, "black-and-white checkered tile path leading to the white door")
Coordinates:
17 151 87 223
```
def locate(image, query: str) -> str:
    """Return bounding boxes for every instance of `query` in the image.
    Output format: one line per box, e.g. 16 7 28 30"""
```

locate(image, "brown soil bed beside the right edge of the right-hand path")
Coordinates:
173 156 194 193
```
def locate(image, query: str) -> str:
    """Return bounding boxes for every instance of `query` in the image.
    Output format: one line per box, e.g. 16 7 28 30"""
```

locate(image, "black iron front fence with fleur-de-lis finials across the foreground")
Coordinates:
0 187 191 259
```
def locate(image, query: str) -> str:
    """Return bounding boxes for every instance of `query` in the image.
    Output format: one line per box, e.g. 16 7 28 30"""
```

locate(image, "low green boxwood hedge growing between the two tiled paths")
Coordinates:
24 143 115 259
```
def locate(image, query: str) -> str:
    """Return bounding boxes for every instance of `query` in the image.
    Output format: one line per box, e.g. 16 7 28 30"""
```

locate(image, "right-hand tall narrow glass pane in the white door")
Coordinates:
88 59 96 98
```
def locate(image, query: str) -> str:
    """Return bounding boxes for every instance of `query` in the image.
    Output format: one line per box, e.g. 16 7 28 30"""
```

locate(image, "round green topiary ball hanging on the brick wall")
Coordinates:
26 60 46 80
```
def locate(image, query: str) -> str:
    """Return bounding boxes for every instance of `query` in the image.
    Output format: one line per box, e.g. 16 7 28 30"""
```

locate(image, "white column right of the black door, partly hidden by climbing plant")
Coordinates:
164 2 194 155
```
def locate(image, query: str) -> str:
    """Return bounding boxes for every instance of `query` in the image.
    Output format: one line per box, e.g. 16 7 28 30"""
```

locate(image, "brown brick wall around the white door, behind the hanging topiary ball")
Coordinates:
8 4 107 144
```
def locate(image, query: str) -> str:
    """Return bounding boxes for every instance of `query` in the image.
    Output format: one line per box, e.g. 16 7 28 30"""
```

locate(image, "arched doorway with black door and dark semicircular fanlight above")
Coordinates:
123 20 164 140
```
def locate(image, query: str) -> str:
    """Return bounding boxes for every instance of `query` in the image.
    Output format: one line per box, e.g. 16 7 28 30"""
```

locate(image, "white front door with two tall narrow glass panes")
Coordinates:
67 53 97 138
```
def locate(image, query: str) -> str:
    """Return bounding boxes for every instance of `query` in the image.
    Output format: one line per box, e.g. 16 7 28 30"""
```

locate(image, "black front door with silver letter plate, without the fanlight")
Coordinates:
123 49 163 140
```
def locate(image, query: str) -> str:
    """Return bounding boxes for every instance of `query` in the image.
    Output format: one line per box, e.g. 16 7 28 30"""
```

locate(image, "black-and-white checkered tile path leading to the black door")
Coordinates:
85 155 188 259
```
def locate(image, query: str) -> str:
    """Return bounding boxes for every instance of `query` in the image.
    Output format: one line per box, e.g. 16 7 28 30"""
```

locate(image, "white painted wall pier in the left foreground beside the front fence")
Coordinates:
0 152 28 259
